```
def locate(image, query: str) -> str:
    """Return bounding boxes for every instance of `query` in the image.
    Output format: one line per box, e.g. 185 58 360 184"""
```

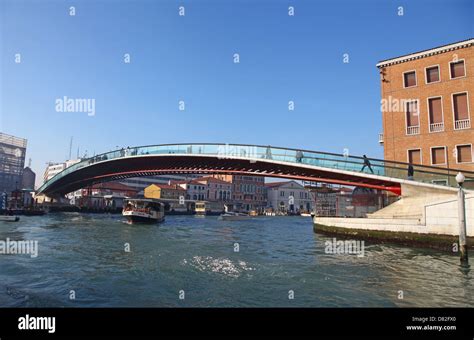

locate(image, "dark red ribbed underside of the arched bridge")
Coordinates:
43 155 401 196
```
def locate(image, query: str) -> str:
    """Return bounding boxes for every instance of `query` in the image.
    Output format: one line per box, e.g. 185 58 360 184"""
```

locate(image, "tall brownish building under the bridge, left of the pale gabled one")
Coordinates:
212 175 267 211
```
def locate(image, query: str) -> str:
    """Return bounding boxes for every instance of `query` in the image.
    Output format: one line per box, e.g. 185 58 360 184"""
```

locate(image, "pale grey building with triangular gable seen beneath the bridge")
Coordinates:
265 181 314 214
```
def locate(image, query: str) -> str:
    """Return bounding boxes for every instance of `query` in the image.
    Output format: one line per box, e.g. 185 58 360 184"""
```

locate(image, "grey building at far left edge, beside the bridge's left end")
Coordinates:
0 132 27 193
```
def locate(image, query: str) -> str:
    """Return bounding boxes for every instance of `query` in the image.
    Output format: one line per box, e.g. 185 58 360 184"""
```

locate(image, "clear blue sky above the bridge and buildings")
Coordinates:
0 0 474 183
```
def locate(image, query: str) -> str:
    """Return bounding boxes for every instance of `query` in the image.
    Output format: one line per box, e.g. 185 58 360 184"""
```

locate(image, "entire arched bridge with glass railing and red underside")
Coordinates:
38 143 474 197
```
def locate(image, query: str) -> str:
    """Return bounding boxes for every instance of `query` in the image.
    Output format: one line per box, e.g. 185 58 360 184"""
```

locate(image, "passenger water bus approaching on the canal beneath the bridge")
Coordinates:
122 199 165 223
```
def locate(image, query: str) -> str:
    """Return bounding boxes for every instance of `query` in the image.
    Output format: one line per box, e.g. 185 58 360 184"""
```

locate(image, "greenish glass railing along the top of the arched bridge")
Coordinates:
38 144 474 192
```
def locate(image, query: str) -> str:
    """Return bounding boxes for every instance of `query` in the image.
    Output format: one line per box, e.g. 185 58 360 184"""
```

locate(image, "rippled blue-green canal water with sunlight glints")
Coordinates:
0 213 474 307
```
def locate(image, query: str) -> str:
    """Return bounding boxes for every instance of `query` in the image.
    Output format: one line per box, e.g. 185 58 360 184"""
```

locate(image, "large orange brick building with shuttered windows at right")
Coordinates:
377 39 474 171
